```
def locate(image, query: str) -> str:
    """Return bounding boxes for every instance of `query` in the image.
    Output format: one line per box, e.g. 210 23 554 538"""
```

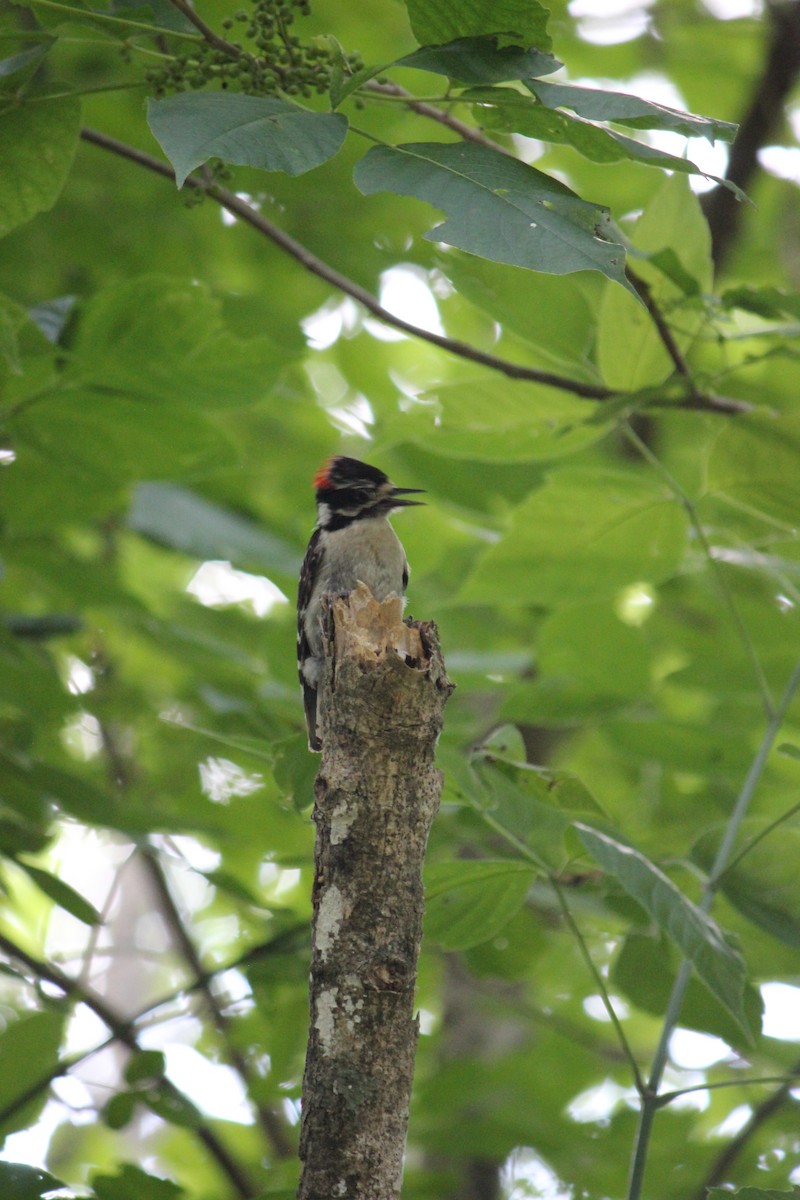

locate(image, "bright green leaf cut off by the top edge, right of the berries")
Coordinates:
405 0 551 50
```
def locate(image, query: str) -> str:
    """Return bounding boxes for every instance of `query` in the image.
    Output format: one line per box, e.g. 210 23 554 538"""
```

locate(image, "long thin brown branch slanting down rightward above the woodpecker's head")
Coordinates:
80 128 751 414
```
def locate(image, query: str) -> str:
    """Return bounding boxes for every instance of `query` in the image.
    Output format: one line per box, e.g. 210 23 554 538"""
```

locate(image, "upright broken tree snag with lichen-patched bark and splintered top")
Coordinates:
297 584 452 1200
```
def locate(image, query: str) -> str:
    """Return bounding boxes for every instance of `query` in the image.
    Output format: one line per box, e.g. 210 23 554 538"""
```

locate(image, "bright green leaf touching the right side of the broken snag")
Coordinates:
425 859 536 950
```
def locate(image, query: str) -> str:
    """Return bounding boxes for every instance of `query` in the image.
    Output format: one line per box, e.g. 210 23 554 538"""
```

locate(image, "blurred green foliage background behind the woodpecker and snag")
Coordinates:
0 0 800 1200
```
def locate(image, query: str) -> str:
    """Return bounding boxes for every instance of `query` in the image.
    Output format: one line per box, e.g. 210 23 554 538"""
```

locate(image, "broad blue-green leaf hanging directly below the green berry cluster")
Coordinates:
148 92 348 187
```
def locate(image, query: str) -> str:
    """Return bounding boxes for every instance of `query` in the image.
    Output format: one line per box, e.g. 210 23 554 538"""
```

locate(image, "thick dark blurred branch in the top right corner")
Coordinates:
702 0 800 269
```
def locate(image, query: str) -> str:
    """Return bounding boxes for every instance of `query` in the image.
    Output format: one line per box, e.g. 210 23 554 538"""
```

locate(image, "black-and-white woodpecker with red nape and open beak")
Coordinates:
297 455 423 750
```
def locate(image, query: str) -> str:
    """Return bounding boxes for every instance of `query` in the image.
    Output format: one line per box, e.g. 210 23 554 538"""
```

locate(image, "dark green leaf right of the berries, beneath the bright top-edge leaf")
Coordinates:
393 37 563 84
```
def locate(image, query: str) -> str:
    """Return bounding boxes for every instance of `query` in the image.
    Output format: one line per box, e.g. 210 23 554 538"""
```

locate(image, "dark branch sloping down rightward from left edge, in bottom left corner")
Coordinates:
0 934 260 1200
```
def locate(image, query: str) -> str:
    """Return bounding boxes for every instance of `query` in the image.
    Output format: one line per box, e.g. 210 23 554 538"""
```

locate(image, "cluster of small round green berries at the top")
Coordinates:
145 0 362 96
